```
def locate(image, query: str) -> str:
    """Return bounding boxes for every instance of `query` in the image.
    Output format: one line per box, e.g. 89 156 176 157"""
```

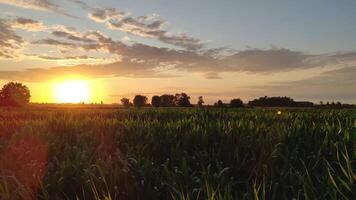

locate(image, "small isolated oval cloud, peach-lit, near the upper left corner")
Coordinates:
11 17 47 32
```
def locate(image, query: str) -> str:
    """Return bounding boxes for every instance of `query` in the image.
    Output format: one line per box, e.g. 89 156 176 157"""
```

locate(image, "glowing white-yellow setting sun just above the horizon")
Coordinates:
54 81 90 103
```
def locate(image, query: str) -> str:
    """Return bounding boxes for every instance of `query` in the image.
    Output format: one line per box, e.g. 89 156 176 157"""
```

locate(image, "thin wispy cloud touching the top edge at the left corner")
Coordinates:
0 0 68 15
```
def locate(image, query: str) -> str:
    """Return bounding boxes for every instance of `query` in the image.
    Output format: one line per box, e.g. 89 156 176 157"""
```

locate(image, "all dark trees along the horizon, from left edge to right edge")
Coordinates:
0 82 356 108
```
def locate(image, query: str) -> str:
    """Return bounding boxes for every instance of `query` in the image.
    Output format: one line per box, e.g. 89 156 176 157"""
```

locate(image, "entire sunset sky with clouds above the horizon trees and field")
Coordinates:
0 0 356 104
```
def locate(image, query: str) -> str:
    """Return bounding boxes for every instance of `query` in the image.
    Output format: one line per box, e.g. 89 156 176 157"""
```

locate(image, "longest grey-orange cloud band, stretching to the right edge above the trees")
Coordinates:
30 27 356 79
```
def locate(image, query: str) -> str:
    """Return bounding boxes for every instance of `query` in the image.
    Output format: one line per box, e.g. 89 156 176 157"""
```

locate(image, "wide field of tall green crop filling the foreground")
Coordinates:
0 107 356 200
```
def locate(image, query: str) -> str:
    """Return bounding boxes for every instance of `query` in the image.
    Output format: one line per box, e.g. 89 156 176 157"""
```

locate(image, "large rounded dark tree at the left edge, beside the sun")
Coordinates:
0 82 31 106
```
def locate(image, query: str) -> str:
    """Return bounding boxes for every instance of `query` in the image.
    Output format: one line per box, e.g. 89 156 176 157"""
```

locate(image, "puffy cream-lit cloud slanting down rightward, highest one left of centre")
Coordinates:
88 8 205 50
